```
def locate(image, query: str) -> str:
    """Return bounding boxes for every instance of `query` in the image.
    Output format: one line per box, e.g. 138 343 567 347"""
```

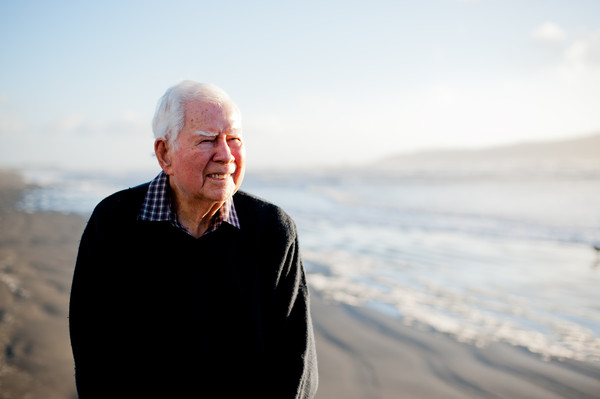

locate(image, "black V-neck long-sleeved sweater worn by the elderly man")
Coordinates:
70 184 317 399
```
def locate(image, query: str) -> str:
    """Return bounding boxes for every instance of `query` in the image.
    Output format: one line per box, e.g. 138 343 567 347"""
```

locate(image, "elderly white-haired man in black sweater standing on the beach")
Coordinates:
70 81 317 399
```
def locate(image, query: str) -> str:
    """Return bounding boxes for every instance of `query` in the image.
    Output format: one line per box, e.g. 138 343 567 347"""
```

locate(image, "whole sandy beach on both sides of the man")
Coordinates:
0 171 600 399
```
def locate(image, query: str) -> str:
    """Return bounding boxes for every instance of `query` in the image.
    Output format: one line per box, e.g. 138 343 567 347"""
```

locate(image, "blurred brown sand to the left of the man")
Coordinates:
0 172 85 399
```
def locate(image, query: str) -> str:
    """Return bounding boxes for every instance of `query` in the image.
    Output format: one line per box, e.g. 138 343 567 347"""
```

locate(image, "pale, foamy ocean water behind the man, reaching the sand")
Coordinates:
20 163 600 362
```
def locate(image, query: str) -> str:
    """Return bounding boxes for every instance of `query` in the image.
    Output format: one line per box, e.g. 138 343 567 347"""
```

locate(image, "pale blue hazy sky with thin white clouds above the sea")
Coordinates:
0 0 600 170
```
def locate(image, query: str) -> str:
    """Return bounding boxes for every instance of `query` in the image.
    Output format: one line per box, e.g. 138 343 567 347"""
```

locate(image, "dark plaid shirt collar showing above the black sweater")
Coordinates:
138 171 240 235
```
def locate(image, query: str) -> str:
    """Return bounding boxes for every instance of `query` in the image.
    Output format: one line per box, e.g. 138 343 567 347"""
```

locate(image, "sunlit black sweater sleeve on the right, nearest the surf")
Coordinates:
272 222 318 399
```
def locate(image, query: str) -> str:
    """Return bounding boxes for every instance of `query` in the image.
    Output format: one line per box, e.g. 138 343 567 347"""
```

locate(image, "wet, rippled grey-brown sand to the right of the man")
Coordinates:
312 292 600 399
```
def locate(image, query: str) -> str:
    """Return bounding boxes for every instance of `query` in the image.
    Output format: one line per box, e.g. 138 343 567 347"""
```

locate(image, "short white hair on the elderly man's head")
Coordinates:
152 80 241 145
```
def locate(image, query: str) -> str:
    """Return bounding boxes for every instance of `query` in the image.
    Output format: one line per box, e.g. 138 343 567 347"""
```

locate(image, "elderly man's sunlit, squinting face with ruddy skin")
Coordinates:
163 100 246 203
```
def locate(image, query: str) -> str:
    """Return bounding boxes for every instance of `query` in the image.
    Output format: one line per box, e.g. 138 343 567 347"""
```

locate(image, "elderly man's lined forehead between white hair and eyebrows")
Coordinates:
184 100 241 133
